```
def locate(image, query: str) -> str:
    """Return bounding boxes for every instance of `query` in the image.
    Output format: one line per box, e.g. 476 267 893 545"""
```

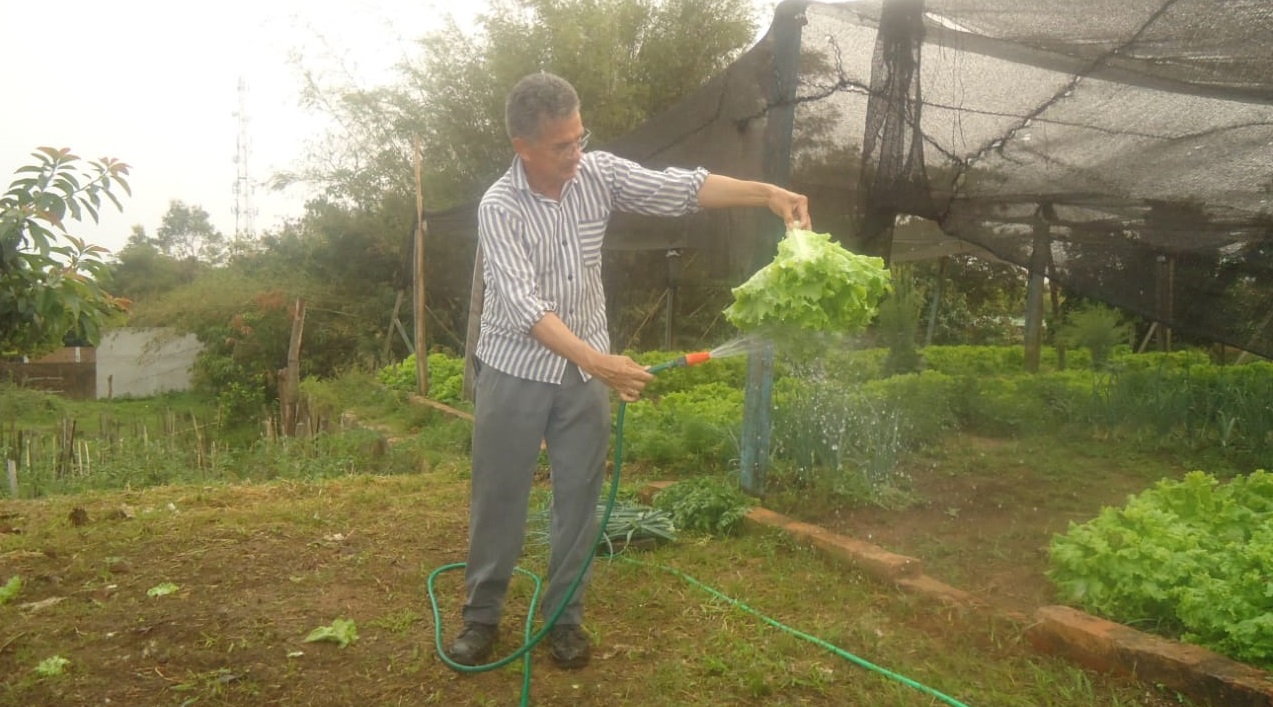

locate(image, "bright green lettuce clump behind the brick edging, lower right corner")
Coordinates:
1049 470 1273 668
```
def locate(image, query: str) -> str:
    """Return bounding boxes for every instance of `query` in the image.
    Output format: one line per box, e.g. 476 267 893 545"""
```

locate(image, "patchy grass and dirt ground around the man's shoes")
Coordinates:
0 464 1191 707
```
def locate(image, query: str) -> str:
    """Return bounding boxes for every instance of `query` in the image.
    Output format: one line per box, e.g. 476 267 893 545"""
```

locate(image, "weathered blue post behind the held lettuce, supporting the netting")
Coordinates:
738 0 808 496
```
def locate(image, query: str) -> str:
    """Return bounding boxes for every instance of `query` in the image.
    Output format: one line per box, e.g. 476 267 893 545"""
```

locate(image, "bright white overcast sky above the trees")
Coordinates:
0 0 777 257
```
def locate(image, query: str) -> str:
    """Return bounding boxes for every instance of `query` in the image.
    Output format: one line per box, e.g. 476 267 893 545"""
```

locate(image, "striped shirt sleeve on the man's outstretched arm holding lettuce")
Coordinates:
598 153 708 217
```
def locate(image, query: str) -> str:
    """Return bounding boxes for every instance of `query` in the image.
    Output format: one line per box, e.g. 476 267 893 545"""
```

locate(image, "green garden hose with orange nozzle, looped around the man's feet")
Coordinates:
426 352 967 707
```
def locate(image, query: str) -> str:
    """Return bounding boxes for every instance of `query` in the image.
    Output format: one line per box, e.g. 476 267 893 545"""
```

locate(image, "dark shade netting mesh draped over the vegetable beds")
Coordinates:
430 0 1273 355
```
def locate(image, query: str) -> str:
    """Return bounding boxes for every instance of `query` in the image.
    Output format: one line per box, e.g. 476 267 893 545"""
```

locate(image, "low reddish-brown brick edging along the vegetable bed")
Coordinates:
639 482 1273 707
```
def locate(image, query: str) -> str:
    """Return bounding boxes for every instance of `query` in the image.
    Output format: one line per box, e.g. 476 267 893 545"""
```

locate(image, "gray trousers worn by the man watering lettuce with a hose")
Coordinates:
463 364 610 624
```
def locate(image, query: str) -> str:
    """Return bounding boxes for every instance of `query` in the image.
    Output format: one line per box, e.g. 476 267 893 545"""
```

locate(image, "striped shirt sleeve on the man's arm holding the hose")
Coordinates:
477 204 558 334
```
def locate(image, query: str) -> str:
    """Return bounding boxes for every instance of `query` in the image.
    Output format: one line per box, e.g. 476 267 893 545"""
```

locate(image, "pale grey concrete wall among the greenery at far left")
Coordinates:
97 329 202 399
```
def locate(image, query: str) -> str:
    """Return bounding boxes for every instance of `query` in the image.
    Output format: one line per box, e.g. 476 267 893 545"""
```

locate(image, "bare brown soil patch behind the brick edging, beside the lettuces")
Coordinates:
784 436 1186 615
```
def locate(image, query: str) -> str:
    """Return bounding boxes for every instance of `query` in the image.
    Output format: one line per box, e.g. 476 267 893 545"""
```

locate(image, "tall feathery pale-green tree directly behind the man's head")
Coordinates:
279 0 755 210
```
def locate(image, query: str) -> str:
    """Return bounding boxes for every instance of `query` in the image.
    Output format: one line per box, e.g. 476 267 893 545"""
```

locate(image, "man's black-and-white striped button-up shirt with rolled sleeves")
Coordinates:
476 152 708 383
